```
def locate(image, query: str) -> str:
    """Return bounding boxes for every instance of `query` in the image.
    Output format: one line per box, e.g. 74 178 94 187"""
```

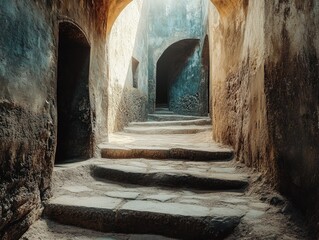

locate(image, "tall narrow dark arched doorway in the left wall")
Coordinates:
56 22 93 163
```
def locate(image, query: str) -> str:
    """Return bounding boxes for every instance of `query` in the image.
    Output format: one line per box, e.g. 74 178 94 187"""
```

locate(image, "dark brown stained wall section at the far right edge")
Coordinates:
265 0 319 231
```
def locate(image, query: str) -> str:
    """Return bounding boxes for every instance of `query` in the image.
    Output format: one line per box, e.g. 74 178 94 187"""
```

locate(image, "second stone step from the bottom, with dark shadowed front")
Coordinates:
92 162 248 190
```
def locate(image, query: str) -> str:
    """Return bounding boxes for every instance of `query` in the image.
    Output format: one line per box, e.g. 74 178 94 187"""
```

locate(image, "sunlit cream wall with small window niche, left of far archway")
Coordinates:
108 0 148 132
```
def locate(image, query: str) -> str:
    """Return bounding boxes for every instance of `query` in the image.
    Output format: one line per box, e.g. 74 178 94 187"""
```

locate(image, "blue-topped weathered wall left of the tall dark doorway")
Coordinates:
0 1 56 239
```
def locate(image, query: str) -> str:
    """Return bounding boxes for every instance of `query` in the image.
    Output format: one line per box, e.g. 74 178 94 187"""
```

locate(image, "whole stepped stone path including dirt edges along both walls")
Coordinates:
23 109 307 240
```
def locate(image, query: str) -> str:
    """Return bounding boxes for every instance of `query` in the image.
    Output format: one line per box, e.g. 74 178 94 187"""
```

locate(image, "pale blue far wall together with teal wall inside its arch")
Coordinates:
148 0 208 115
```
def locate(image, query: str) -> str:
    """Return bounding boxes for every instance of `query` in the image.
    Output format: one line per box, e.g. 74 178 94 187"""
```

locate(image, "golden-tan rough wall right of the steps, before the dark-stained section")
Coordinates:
209 1 275 172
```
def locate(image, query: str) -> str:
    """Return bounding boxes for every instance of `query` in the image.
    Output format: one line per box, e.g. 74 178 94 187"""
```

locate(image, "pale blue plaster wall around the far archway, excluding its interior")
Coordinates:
148 0 207 112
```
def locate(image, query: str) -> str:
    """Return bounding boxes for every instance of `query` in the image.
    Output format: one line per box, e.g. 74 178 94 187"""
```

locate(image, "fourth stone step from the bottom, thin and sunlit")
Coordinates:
124 125 212 135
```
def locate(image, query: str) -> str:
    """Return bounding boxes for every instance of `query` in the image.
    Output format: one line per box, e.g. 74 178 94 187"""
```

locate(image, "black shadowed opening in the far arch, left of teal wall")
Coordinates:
156 39 199 107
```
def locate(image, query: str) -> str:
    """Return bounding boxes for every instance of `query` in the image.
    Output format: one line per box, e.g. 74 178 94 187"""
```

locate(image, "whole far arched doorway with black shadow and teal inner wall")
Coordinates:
156 39 209 115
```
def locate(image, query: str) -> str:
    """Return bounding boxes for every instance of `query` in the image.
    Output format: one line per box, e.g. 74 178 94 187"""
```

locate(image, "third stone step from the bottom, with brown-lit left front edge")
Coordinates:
100 144 234 161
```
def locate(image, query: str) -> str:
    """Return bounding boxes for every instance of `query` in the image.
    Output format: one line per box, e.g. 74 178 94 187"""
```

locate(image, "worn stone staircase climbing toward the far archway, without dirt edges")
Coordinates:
41 113 249 239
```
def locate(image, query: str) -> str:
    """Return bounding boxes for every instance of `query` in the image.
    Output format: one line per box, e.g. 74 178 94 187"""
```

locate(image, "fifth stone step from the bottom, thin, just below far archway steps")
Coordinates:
129 118 212 127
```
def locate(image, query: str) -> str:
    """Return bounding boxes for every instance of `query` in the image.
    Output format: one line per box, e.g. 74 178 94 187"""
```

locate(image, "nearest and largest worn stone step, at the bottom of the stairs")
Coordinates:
44 195 244 239
